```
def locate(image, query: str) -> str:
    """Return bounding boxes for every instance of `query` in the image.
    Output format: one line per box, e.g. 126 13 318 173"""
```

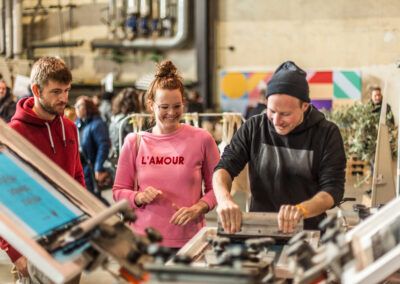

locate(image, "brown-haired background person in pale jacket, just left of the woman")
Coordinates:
108 88 140 157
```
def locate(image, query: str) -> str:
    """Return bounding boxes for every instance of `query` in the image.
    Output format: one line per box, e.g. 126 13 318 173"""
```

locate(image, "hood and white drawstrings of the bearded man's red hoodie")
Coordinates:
11 97 66 153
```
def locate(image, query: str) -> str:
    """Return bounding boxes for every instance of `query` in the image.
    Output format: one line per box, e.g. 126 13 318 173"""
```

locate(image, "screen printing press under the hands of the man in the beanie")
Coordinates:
145 213 320 284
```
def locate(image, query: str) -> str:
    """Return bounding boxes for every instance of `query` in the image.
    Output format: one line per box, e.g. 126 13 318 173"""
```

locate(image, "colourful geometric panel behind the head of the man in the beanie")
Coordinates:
219 70 361 114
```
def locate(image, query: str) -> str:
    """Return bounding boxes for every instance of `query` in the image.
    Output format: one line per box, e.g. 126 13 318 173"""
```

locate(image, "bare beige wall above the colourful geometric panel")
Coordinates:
216 0 400 120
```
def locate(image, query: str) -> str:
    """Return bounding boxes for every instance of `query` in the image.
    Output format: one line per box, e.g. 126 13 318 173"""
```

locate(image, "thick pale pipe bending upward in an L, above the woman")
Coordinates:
91 0 189 50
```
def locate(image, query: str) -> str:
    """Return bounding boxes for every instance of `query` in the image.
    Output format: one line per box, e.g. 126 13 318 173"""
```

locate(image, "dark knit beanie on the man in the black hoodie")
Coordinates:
266 61 310 103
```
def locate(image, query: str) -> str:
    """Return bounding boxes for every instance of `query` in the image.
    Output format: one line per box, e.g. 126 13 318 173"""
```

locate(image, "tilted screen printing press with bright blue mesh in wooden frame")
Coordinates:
0 120 160 283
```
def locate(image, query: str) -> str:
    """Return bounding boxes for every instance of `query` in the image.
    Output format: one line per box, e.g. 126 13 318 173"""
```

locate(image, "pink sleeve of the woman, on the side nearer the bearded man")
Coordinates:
112 134 142 208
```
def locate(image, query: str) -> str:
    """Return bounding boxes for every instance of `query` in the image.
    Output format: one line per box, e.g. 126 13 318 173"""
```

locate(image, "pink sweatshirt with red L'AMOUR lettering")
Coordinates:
113 124 219 248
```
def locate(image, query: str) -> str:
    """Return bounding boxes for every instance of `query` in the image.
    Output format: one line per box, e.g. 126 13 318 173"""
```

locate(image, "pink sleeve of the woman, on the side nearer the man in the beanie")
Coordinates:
201 133 219 210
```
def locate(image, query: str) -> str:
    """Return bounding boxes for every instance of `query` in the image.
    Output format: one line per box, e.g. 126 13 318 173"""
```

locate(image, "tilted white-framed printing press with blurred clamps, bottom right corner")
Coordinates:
289 198 400 284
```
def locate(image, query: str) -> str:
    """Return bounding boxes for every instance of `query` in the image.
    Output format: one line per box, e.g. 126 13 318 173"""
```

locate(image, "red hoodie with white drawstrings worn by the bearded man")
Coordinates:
0 97 85 262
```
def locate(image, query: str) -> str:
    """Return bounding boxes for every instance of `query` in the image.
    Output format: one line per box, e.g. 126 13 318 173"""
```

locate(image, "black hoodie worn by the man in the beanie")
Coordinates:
216 106 346 230
